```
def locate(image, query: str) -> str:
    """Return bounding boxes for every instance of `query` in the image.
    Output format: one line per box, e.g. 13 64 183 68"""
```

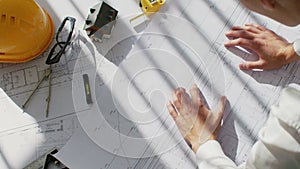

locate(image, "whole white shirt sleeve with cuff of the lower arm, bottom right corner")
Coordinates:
196 87 300 169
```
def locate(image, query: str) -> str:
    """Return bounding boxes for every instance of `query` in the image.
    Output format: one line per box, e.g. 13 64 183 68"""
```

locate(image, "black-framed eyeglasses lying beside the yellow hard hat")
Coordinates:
46 16 76 65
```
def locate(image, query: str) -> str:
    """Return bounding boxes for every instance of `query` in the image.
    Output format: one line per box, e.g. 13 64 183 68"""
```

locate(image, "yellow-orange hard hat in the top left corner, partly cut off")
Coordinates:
0 0 54 63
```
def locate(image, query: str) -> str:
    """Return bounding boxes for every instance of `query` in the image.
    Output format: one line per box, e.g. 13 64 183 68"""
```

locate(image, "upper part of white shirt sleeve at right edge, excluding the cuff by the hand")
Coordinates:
246 88 300 169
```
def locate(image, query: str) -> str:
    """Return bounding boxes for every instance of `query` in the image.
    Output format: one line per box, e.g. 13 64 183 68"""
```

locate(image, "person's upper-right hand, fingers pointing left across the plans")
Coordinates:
224 24 300 70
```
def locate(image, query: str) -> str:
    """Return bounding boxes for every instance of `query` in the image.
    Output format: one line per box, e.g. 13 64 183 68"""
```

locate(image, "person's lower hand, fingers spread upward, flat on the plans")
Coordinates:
167 85 226 153
